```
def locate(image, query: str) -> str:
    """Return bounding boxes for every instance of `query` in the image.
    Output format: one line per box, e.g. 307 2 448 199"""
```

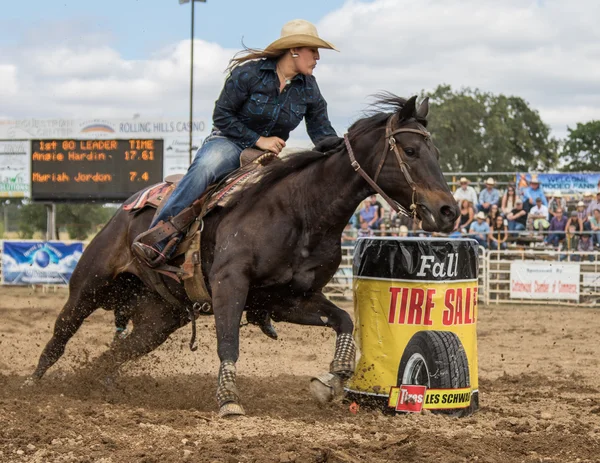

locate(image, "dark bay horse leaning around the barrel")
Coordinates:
31 94 458 415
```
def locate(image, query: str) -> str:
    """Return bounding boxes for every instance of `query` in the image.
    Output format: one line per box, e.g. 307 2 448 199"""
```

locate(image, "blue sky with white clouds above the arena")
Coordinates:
0 0 600 146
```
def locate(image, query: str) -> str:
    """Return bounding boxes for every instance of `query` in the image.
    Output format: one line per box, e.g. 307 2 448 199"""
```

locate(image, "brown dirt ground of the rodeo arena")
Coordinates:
0 287 600 463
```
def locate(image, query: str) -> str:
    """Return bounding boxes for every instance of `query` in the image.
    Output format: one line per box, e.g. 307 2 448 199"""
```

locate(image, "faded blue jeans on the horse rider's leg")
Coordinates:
150 135 243 231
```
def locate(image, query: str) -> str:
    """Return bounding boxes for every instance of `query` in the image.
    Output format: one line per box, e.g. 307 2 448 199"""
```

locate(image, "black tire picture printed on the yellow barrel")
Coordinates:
397 331 471 414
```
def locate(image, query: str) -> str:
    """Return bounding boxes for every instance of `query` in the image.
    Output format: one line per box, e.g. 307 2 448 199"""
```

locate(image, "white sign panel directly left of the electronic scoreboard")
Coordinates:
0 140 31 198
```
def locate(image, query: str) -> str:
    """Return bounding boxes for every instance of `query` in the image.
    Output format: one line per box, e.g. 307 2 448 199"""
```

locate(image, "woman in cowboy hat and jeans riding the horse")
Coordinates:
132 19 337 267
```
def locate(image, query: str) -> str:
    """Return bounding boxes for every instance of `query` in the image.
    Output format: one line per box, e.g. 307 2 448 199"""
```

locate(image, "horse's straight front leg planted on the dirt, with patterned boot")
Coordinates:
211 271 249 416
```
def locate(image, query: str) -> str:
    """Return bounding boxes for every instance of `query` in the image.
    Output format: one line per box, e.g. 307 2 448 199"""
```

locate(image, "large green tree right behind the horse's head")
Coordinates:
428 85 559 172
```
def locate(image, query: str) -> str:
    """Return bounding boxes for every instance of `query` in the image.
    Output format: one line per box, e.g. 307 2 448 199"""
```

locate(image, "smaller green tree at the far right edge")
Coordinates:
562 121 600 172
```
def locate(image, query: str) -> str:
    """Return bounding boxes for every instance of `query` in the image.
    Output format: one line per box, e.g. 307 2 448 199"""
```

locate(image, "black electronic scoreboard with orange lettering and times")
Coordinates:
31 138 163 202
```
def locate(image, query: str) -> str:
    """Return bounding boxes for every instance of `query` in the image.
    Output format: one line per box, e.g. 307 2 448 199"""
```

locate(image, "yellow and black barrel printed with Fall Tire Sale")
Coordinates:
346 238 479 416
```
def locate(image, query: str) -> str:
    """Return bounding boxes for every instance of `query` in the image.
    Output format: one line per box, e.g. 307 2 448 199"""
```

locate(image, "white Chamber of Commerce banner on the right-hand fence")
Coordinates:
510 262 580 301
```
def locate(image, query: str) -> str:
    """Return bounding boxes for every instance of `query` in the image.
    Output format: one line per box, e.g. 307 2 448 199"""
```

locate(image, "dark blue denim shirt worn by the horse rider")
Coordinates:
213 59 337 148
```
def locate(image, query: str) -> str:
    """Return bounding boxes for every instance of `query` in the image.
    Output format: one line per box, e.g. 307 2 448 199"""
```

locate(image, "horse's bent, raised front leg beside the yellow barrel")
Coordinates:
273 292 356 402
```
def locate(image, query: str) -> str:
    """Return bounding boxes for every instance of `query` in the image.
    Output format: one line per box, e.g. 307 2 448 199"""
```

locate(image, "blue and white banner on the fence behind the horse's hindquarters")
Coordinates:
2 241 83 285
